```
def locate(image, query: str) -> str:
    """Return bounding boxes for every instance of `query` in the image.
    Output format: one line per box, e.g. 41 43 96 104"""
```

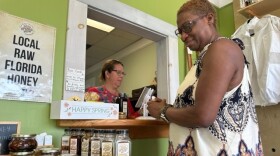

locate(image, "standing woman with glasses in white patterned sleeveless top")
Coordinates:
148 0 262 156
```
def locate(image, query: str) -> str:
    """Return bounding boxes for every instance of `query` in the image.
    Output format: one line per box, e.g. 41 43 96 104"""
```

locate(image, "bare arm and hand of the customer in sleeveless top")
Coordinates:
148 39 244 127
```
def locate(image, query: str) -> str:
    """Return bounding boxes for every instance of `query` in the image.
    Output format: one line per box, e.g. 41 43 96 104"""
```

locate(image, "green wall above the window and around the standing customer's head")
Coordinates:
119 0 235 82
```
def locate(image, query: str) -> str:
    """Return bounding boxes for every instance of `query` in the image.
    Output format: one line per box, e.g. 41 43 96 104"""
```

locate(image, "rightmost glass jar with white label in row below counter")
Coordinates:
115 129 131 156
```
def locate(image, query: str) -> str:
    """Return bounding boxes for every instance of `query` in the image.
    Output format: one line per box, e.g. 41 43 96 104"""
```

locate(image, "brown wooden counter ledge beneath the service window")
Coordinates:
57 119 169 139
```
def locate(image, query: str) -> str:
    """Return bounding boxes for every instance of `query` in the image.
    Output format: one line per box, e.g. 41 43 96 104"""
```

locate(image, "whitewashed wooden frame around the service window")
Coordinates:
63 0 179 103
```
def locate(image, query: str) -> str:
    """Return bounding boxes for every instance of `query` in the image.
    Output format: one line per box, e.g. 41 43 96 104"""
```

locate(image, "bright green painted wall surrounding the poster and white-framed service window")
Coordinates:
0 0 234 156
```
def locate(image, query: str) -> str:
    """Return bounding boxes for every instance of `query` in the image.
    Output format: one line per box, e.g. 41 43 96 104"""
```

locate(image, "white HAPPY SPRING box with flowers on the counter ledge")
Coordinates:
50 100 119 119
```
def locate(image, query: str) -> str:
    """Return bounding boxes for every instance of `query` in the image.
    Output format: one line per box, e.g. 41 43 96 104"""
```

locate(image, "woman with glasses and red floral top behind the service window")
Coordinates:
85 59 140 118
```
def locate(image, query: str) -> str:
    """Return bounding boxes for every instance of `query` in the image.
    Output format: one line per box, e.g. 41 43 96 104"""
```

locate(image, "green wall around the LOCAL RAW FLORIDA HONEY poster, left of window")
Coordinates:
0 0 68 146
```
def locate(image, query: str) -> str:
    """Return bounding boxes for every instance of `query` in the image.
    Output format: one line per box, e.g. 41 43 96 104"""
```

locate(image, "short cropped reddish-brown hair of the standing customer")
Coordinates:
177 0 217 27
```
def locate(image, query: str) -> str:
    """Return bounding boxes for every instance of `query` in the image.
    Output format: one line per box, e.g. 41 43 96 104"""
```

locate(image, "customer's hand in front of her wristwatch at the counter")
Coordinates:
147 98 166 119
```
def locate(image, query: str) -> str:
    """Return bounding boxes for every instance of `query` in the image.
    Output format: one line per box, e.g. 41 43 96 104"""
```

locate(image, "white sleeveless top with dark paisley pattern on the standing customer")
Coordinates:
167 39 263 156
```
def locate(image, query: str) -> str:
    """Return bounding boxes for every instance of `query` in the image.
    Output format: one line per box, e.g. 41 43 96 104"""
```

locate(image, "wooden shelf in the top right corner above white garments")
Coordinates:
238 0 280 18
